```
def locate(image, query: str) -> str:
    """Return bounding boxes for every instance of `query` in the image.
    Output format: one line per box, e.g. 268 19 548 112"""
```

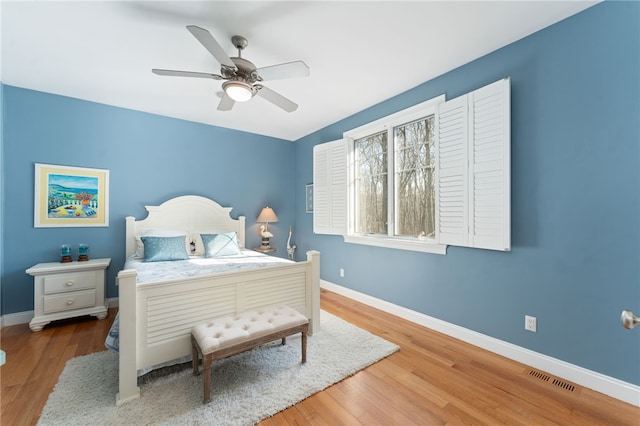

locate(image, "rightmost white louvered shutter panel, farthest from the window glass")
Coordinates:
469 79 511 250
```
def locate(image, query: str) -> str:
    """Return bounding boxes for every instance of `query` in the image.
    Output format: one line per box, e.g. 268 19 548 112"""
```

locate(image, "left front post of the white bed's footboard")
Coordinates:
116 269 140 405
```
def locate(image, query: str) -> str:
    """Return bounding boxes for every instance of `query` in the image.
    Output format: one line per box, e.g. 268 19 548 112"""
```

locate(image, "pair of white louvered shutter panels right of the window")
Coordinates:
436 78 511 251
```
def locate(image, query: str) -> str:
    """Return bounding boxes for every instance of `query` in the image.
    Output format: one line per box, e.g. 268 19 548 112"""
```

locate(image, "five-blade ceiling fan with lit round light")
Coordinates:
151 25 309 112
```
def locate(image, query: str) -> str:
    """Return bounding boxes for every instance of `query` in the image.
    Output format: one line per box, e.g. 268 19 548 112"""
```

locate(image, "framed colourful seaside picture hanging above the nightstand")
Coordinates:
33 163 109 228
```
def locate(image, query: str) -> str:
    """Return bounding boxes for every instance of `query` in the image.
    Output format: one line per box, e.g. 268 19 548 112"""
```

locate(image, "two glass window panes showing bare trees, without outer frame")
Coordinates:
353 114 435 238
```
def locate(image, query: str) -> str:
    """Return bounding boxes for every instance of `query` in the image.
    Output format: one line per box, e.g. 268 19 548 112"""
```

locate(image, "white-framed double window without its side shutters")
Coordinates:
345 96 444 252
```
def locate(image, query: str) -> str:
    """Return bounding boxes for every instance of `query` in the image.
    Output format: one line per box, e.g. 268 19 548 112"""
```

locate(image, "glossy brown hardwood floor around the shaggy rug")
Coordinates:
0 290 640 426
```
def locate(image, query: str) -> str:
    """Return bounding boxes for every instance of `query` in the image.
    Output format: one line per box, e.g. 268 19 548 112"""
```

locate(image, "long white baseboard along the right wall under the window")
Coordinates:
320 280 640 407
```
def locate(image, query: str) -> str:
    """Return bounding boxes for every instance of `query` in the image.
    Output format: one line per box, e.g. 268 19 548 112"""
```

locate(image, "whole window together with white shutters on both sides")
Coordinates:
314 78 511 254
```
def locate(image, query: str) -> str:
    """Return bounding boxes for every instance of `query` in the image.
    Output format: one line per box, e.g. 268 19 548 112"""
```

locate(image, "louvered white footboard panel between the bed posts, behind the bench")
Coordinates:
137 262 311 368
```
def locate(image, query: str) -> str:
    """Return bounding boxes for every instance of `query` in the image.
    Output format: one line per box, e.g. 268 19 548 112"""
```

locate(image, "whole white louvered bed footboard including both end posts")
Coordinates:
116 251 320 405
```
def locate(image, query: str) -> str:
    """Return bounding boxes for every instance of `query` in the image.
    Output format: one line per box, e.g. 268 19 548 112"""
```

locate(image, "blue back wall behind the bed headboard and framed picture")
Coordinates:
2 85 294 314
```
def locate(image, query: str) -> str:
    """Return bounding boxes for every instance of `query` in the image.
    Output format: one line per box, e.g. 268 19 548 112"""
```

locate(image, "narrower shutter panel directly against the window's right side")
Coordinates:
435 95 468 246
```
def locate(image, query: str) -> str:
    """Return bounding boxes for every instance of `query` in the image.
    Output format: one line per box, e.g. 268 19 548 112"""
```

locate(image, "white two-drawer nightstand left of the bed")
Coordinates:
26 258 111 331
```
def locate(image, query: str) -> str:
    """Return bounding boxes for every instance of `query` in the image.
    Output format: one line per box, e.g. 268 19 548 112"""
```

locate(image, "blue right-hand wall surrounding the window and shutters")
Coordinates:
295 2 640 384
